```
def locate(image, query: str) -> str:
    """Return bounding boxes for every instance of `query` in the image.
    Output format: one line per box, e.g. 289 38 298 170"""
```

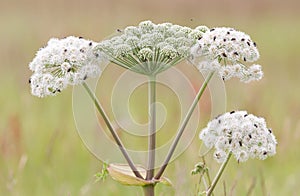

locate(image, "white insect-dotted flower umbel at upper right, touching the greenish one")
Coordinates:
191 27 263 82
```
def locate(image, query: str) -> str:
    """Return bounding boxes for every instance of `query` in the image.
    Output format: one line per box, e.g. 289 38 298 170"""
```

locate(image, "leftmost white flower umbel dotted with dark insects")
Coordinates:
29 36 103 97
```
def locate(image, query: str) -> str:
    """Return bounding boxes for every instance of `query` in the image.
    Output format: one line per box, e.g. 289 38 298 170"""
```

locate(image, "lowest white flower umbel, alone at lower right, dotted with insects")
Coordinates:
199 111 277 162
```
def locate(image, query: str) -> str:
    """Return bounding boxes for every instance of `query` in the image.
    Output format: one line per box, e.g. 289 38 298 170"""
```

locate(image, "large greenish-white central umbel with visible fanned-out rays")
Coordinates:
97 21 209 75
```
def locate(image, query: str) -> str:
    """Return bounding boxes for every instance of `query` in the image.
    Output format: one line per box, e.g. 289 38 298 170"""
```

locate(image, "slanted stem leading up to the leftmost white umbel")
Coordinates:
82 82 143 178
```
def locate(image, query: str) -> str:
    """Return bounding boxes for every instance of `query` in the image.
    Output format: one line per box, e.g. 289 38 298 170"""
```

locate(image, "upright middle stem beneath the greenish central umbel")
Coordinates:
146 76 156 180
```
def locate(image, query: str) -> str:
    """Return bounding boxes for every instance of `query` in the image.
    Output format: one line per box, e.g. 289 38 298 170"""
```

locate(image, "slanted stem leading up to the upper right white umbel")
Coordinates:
155 72 214 179
